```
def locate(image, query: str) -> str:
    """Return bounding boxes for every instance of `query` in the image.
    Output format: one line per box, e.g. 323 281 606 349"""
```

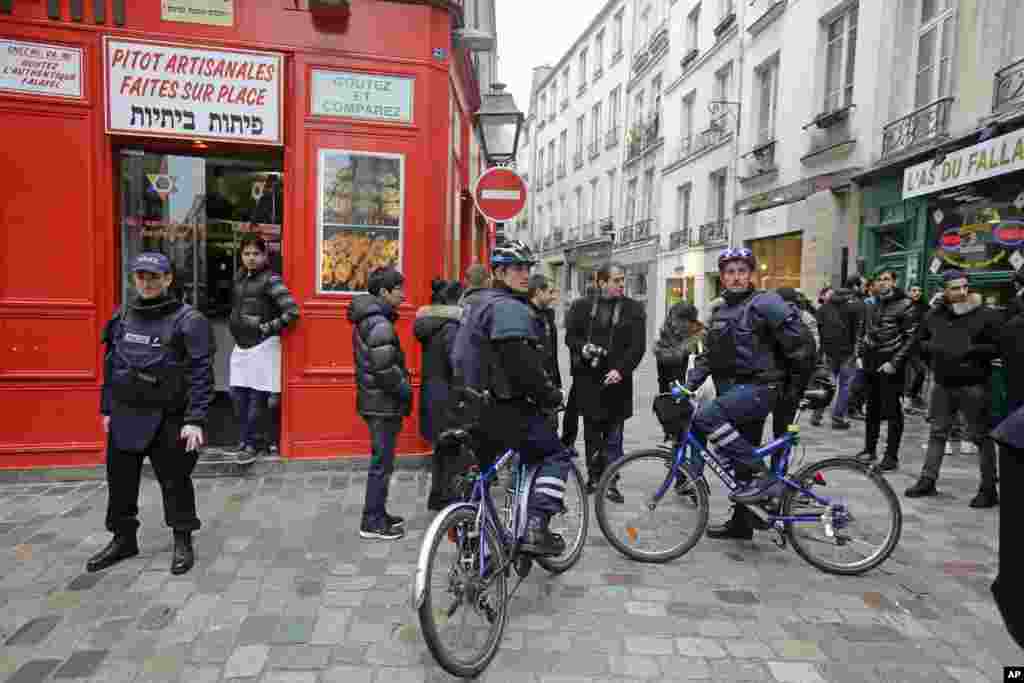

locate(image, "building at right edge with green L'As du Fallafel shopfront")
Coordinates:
857 0 1024 305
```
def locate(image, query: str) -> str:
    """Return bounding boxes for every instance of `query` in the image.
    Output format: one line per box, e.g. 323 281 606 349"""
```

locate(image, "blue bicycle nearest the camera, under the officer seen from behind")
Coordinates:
413 430 590 678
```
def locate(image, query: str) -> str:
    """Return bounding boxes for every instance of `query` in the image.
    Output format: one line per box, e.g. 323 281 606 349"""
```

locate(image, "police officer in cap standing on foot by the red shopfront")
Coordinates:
86 252 214 574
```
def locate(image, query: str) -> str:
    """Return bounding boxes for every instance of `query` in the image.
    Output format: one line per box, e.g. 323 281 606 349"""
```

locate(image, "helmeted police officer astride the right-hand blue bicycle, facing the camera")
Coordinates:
686 248 814 539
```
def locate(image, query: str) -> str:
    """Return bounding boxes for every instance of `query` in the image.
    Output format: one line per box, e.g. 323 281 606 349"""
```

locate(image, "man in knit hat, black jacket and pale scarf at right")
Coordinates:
906 270 999 508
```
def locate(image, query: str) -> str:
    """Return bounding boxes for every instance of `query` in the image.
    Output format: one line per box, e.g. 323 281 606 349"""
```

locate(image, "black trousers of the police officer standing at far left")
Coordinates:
106 419 200 536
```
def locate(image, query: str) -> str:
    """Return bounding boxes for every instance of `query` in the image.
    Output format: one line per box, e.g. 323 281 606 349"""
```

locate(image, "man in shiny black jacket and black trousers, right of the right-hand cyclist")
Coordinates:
856 270 921 471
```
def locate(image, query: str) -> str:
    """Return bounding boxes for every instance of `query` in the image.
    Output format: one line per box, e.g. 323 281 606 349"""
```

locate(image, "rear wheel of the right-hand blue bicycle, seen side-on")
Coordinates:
780 458 903 575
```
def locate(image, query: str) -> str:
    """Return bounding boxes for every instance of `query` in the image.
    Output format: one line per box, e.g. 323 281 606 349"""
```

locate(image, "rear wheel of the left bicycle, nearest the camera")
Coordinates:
419 508 508 678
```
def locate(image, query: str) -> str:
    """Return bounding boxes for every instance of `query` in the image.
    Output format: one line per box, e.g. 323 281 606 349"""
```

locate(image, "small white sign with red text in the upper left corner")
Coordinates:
0 40 82 99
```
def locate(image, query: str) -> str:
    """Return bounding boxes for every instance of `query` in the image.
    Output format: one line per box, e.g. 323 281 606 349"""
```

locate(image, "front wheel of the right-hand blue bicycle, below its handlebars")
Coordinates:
594 450 708 562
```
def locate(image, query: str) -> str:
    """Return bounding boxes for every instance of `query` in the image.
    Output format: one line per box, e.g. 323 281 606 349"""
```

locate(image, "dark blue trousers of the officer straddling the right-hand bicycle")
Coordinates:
693 384 779 479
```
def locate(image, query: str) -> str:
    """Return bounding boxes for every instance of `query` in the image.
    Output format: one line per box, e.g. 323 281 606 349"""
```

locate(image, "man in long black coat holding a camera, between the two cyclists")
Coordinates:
565 262 647 503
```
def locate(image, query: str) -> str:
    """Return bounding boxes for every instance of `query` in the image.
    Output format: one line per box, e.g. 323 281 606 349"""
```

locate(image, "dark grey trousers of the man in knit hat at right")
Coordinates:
921 384 995 489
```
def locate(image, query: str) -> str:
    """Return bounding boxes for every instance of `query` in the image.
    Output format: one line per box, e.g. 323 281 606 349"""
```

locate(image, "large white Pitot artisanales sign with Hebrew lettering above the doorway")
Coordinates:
104 38 284 144
